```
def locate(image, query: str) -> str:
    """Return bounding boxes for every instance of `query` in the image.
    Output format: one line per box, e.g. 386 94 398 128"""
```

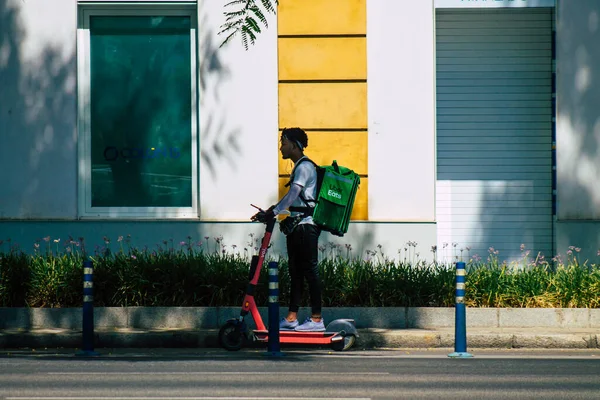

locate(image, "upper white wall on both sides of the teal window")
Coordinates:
0 0 278 221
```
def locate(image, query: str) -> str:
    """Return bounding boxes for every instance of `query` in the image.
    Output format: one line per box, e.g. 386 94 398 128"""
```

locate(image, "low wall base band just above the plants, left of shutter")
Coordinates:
0 220 436 261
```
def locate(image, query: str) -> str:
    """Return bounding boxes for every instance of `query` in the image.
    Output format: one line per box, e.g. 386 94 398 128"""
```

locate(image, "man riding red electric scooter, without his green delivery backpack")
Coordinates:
219 128 359 351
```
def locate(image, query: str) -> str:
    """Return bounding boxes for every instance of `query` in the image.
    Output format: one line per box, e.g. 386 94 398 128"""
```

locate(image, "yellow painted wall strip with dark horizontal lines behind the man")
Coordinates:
278 0 368 220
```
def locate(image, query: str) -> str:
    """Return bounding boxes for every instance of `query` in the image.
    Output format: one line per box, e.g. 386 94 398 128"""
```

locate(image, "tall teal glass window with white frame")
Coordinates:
78 5 198 218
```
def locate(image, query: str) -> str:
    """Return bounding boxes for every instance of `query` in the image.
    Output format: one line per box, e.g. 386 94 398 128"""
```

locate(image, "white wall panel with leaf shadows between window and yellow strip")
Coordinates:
198 0 279 221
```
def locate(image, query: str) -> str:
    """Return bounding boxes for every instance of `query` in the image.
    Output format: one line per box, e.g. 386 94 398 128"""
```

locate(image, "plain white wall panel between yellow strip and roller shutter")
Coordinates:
367 0 435 221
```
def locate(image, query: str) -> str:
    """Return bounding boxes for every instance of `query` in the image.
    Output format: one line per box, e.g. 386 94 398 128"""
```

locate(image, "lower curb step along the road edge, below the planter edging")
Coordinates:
0 328 600 350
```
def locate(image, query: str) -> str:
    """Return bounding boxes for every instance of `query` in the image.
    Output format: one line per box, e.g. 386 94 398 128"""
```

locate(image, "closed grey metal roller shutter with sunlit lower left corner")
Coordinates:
436 8 553 261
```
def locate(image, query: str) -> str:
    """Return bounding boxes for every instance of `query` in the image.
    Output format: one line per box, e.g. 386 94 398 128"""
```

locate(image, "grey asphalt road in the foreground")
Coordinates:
0 349 600 400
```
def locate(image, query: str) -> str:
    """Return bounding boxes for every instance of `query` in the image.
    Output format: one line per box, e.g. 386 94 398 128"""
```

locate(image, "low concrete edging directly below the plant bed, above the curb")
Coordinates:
0 307 600 332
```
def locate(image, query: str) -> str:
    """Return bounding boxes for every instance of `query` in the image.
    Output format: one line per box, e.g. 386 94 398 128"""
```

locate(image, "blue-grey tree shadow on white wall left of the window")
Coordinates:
0 0 77 218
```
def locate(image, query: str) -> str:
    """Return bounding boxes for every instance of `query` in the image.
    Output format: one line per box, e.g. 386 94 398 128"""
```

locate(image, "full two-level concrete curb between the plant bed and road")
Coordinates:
0 307 600 349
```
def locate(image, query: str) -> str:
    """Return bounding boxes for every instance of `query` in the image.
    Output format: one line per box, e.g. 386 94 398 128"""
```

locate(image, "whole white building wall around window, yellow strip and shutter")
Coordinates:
0 0 600 260
